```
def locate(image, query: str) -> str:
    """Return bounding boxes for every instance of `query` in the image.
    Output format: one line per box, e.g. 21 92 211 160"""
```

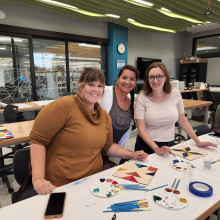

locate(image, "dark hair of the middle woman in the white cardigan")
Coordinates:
114 64 139 129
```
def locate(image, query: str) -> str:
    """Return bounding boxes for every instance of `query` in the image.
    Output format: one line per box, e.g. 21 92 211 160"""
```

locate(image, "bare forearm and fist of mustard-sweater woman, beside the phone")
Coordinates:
31 144 56 194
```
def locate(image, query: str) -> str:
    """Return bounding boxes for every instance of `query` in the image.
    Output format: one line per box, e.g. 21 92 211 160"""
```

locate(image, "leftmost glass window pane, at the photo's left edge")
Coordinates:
0 36 32 101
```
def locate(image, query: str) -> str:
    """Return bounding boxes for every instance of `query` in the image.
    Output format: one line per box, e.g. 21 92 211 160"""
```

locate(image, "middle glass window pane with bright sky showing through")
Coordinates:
33 38 67 100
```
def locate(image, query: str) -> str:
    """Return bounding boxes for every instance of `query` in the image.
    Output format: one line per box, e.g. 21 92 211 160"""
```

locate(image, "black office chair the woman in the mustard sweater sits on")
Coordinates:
11 148 37 203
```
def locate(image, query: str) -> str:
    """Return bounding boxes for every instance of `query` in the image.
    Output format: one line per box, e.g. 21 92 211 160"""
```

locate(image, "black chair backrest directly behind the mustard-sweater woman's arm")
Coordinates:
13 148 30 185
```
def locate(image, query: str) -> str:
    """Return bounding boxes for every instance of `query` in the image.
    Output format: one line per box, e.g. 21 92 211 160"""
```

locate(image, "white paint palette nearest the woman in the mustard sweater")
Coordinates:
90 178 120 197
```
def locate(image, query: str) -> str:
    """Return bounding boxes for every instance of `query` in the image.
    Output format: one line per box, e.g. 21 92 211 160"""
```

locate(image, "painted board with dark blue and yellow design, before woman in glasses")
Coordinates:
172 146 207 160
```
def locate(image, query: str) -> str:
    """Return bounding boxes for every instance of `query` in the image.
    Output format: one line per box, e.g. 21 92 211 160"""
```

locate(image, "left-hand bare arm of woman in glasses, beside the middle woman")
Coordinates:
137 119 171 155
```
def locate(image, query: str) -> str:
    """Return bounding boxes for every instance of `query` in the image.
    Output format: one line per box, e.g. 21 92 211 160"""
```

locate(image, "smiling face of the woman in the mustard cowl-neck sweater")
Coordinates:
80 80 104 111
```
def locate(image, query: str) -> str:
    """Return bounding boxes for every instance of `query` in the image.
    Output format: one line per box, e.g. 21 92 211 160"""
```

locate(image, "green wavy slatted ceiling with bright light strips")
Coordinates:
0 0 220 33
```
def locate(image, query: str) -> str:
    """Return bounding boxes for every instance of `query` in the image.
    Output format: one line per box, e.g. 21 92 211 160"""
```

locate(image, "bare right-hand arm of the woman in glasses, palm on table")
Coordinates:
178 114 217 147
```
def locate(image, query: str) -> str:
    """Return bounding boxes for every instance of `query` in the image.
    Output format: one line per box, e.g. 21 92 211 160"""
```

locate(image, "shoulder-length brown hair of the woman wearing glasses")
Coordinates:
144 62 172 95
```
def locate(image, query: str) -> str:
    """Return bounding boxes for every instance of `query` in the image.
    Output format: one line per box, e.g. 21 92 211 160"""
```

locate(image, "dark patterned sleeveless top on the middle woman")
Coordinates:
109 87 131 143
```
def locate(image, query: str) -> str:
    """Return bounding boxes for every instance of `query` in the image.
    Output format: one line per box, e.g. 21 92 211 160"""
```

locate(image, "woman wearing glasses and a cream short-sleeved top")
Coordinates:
135 62 217 155
